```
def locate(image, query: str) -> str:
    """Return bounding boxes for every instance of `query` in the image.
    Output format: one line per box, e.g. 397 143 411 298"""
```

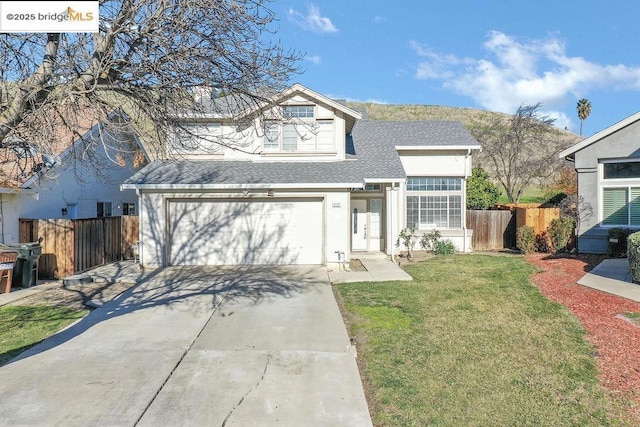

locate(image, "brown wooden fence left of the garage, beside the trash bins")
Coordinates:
20 216 138 279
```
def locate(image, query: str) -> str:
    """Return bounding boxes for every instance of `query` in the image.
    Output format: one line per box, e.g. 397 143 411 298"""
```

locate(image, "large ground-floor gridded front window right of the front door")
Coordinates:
407 177 462 230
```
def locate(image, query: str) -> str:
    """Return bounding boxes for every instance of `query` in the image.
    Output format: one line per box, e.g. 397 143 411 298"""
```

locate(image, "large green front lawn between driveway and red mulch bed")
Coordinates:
335 254 621 426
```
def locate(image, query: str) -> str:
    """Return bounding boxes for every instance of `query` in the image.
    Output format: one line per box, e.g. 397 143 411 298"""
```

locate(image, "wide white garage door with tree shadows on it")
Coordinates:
168 199 323 265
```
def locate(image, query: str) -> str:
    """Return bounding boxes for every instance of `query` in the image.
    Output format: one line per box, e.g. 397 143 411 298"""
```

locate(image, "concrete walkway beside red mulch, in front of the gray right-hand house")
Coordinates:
578 258 640 302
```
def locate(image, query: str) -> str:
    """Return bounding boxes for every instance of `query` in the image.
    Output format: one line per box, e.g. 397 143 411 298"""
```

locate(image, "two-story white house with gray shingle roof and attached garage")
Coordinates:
122 84 480 266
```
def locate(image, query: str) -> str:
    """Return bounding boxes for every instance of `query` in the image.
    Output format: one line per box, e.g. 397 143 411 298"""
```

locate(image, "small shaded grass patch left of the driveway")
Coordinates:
0 305 88 366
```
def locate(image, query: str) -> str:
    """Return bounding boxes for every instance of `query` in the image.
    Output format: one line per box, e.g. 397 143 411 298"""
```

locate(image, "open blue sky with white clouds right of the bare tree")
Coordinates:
271 0 640 136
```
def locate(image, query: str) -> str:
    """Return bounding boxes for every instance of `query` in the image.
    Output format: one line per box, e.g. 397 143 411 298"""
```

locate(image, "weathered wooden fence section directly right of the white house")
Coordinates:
467 210 516 251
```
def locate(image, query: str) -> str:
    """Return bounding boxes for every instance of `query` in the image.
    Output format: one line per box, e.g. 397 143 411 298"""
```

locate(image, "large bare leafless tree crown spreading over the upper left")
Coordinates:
0 0 301 187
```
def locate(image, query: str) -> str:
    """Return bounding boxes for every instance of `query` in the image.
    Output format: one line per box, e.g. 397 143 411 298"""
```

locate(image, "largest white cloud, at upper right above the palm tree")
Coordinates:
410 31 640 128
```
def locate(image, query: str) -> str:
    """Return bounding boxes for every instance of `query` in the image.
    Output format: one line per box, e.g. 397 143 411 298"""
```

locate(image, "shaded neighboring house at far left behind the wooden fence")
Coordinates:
0 118 146 244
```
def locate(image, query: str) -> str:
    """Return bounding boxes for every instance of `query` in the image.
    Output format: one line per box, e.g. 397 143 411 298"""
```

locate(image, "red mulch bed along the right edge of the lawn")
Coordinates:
526 253 640 424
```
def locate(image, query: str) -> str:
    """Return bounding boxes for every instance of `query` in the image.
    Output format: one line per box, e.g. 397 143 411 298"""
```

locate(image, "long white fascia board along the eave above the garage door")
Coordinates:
120 182 364 190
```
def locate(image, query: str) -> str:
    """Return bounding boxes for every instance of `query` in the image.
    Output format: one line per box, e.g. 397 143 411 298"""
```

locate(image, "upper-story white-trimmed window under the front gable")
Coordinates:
263 105 335 152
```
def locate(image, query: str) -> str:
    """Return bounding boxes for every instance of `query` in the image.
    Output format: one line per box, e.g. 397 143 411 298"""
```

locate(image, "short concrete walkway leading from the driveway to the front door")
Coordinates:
329 253 413 283
